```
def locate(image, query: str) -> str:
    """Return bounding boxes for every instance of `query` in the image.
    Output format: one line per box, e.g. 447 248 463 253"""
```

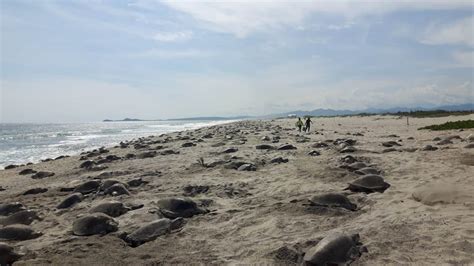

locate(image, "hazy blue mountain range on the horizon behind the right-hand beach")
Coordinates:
265 103 474 118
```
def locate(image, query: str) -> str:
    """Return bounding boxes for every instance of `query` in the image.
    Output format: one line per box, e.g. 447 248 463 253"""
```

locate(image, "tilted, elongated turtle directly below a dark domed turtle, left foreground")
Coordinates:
122 218 184 247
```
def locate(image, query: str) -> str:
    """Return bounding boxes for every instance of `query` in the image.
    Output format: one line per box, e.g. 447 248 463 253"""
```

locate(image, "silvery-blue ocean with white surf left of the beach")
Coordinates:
0 120 232 169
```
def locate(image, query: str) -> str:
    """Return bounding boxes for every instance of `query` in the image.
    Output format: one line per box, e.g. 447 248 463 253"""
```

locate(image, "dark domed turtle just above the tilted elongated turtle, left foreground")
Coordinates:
157 198 208 219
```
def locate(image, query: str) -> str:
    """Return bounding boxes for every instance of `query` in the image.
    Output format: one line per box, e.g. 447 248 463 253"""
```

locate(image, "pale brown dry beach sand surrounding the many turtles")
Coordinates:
0 115 474 265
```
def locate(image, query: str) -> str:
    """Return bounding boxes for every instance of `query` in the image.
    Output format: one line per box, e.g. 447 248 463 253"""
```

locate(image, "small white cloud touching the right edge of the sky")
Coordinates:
420 16 474 46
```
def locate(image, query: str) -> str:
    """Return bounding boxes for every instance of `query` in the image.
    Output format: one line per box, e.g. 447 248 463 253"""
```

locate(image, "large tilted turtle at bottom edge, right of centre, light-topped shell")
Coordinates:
303 232 368 265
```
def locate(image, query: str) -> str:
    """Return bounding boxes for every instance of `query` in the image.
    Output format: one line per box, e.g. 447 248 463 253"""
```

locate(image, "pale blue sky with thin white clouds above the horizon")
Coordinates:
0 0 474 122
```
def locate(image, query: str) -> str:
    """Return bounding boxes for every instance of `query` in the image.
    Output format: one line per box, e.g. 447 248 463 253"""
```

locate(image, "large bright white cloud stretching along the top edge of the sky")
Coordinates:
162 0 472 38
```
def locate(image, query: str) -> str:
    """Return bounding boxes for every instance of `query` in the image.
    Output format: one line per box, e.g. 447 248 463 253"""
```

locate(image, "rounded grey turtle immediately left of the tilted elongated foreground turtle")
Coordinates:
72 213 118 236
